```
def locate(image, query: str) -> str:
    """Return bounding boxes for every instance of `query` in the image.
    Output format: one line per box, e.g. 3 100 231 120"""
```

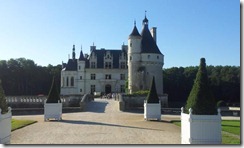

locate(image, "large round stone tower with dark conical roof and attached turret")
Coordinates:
127 15 164 95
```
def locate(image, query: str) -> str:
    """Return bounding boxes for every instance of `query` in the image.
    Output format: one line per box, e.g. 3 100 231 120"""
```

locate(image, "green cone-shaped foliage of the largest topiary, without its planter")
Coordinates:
185 58 217 115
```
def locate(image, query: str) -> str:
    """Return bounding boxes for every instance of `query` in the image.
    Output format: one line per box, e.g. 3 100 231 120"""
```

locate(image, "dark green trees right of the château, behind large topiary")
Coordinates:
163 66 240 107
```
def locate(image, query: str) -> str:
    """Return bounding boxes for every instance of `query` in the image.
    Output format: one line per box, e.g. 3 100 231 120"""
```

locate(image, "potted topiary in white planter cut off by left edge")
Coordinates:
0 80 12 144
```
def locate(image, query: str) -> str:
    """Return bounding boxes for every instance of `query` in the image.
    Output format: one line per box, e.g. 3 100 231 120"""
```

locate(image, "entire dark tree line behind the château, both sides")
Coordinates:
0 58 240 107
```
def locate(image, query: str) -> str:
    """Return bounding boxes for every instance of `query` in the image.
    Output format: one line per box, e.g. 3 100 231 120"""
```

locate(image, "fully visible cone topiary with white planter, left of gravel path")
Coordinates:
44 78 62 121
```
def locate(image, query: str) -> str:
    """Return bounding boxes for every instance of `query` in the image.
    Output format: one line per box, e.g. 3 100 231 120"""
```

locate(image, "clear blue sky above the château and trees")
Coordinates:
0 0 240 68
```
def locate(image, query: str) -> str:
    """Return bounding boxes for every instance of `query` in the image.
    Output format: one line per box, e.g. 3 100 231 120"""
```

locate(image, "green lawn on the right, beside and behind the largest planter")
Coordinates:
172 120 241 144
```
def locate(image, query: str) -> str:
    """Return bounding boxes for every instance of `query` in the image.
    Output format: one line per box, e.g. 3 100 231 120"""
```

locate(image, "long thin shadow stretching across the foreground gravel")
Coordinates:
59 120 164 131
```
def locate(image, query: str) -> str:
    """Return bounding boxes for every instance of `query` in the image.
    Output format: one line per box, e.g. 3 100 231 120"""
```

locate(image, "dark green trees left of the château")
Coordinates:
0 58 62 96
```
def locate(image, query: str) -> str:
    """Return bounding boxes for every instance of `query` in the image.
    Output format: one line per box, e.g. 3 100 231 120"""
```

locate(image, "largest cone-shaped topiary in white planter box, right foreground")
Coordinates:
181 58 222 144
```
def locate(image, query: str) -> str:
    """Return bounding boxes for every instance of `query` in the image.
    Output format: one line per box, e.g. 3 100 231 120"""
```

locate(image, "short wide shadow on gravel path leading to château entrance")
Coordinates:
85 101 108 113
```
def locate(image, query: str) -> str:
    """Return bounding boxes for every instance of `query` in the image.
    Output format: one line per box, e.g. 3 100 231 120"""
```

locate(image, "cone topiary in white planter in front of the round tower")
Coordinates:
144 77 161 120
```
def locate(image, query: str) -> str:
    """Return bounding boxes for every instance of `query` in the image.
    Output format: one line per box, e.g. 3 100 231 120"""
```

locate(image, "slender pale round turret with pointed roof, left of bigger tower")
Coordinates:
127 23 142 93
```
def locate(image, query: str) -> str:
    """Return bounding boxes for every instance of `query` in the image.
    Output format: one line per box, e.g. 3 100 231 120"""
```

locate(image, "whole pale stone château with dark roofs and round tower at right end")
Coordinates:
61 16 164 95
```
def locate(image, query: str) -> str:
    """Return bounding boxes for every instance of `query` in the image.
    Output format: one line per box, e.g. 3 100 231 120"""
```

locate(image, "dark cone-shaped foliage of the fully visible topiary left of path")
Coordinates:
47 77 61 103
